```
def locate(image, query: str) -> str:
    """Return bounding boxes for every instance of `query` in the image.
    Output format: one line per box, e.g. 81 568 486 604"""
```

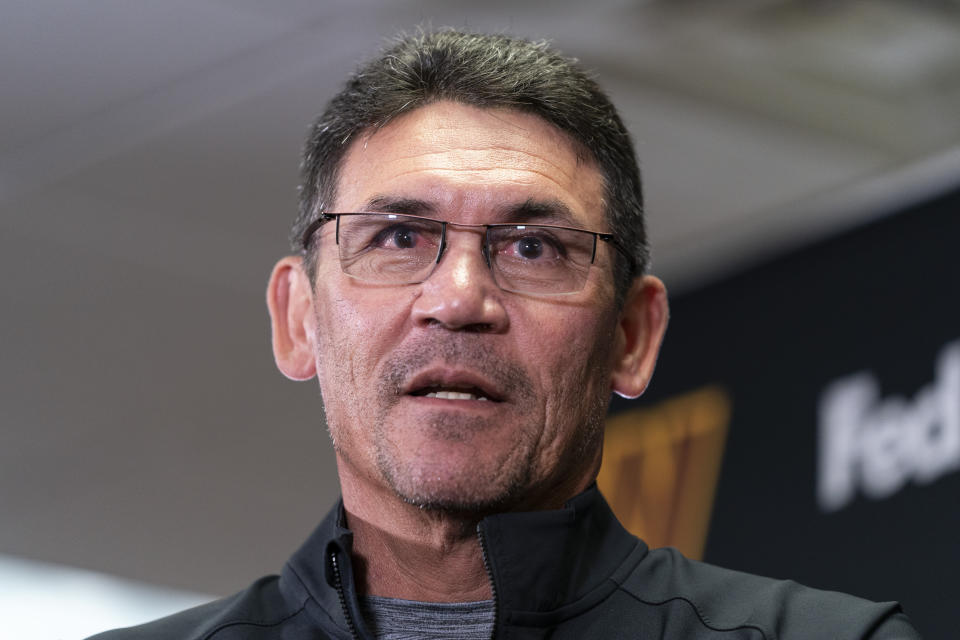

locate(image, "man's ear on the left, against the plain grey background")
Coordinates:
267 256 317 380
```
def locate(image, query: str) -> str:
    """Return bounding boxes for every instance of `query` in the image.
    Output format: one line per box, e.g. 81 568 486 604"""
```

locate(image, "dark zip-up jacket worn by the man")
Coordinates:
91 487 919 640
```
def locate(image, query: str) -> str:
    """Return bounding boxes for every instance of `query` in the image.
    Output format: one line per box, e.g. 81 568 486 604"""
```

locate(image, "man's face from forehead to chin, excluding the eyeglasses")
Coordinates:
304 102 622 511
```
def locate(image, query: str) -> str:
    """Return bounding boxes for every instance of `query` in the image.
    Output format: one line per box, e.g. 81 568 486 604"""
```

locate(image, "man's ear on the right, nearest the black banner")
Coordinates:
611 276 670 398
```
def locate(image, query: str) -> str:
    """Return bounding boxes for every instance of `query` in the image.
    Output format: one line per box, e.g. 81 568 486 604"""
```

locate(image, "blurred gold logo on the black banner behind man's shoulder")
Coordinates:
597 387 731 559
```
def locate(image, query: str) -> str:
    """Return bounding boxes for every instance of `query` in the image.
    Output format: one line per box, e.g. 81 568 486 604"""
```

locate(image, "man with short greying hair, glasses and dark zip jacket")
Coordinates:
92 32 917 640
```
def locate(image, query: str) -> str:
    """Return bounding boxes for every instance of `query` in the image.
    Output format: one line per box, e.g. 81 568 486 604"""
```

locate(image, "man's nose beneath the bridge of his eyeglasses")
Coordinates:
412 227 509 333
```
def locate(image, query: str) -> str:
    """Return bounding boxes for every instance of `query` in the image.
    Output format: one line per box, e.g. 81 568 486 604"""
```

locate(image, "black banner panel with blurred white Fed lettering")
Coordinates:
604 182 960 638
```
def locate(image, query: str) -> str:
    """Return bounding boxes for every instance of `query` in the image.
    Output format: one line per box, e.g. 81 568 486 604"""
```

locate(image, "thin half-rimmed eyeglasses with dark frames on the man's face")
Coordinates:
302 213 633 295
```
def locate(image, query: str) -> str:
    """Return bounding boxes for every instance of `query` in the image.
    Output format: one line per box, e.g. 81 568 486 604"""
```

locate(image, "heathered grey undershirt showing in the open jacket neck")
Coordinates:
360 596 493 640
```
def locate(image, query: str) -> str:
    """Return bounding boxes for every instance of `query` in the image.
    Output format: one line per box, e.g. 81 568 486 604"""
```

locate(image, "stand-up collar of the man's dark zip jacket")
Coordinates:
281 485 647 637
